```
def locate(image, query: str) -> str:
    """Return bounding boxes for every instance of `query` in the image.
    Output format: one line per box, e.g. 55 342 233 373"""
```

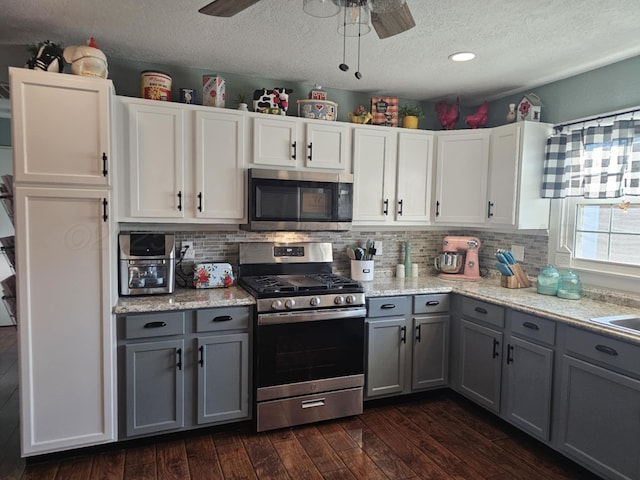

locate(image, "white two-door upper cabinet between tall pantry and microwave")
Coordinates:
118 97 247 224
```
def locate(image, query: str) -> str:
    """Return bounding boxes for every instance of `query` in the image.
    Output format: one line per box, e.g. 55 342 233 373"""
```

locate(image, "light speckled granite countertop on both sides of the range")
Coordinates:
113 276 640 344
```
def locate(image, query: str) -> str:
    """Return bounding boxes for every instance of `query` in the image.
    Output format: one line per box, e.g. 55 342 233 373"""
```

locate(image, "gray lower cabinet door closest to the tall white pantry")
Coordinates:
125 340 184 436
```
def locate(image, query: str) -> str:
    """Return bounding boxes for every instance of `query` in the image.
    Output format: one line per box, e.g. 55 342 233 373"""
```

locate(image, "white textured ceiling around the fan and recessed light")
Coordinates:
0 0 640 104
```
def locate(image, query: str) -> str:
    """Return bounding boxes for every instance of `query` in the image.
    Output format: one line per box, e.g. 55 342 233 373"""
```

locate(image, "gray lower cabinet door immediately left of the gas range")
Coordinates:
198 333 249 424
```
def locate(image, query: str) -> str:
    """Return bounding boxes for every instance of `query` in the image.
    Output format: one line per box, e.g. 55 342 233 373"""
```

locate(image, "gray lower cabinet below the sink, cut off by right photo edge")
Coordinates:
558 327 640 480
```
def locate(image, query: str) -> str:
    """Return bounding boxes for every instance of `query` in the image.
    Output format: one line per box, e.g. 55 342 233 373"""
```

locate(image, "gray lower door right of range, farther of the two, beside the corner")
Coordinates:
411 315 449 390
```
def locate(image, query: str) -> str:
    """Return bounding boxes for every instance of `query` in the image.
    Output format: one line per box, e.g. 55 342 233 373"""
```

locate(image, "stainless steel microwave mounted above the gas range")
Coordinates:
242 168 353 231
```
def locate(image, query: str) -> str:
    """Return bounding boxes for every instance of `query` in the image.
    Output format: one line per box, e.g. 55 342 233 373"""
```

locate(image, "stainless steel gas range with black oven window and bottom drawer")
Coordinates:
238 243 366 431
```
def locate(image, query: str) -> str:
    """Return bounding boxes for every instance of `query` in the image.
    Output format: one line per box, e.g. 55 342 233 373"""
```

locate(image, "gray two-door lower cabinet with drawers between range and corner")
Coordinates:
365 294 449 399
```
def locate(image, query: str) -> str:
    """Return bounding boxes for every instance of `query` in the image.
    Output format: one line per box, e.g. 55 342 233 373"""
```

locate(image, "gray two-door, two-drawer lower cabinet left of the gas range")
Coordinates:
118 307 250 438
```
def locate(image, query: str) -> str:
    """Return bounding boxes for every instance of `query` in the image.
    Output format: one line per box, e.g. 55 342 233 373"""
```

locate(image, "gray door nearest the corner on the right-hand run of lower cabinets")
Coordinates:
459 319 502 413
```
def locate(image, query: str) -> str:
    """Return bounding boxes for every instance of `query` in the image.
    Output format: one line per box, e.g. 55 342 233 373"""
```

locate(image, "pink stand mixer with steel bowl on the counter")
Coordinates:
434 236 480 280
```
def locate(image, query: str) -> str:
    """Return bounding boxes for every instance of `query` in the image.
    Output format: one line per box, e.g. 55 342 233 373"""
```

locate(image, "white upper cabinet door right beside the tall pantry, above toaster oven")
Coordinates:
126 104 185 218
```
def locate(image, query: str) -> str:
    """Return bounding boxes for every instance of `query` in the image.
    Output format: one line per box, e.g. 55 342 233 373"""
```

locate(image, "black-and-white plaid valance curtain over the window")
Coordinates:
542 120 640 198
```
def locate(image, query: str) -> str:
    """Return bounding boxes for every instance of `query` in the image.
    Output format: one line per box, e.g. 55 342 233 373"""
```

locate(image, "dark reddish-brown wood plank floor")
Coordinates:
0 327 598 480
